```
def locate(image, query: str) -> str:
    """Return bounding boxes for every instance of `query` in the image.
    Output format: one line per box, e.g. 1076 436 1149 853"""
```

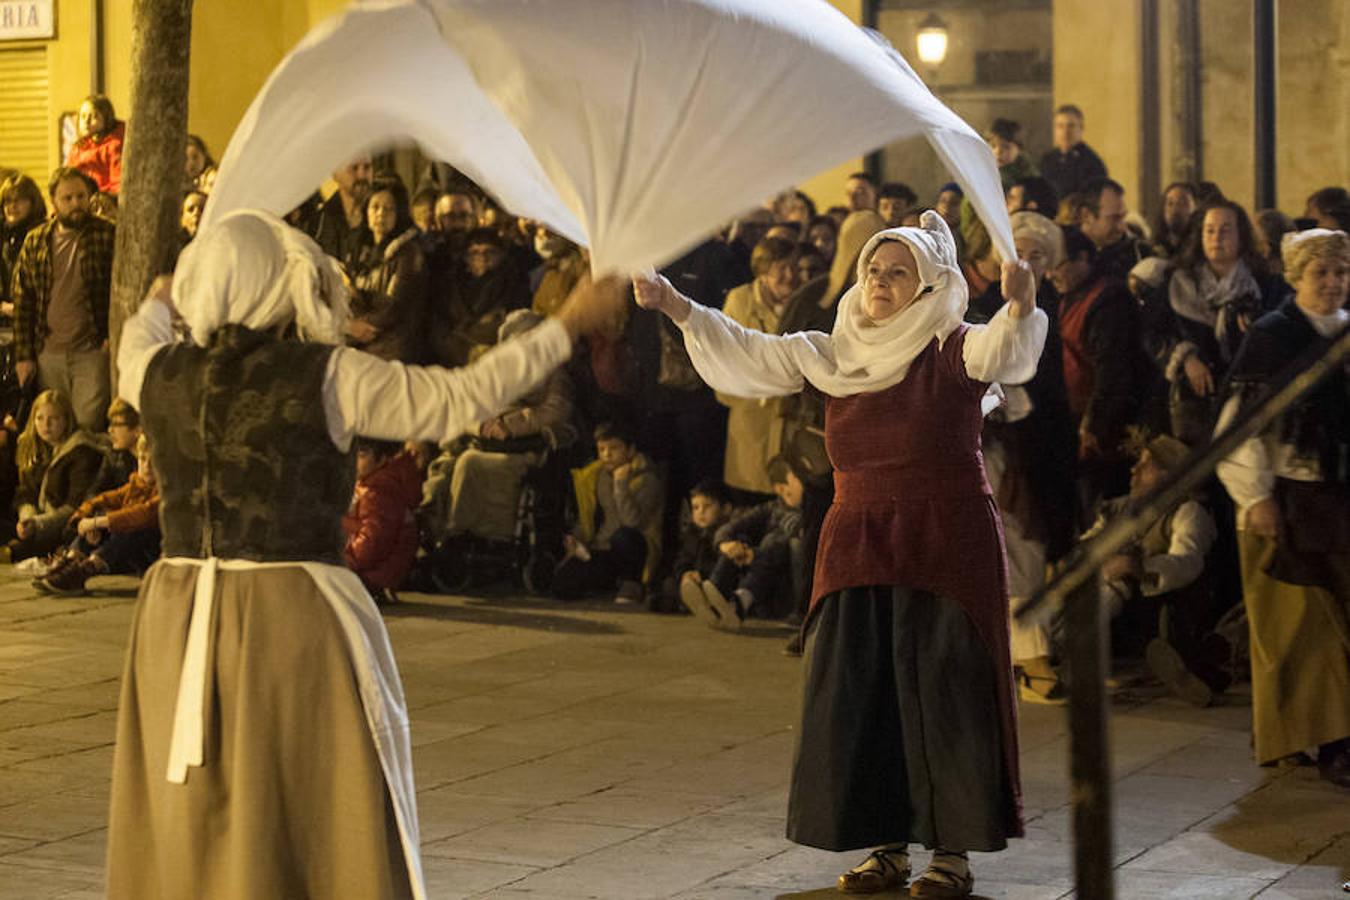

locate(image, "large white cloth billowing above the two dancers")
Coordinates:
203 0 1015 273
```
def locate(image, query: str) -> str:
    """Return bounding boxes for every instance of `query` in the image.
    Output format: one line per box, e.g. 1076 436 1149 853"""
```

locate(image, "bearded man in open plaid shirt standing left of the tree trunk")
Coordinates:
14 167 116 432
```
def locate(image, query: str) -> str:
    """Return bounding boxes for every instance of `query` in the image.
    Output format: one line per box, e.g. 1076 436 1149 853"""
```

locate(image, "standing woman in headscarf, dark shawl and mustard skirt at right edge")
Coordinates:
1219 228 1350 787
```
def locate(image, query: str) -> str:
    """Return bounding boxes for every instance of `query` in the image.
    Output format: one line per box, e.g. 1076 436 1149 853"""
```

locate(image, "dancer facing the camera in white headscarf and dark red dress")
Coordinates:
636 212 1048 897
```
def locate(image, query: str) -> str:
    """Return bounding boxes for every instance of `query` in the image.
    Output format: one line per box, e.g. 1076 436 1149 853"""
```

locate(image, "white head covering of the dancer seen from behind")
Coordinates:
173 209 347 347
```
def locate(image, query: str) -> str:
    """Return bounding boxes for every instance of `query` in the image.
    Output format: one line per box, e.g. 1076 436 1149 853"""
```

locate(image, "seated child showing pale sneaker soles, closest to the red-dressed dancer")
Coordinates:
680 456 805 630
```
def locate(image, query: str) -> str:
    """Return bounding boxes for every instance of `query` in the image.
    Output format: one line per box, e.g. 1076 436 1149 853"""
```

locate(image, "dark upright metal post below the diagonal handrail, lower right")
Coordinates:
1064 582 1115 900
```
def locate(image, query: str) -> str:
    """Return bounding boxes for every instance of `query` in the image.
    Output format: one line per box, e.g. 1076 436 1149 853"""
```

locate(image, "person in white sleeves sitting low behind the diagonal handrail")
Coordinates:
1083 434 1229 706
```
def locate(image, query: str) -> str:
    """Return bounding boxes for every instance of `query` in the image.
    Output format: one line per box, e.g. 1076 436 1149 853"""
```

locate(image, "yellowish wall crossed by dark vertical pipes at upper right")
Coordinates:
1054 0 1350 216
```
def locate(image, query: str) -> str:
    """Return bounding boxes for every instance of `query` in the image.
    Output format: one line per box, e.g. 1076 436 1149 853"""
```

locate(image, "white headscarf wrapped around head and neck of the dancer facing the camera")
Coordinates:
811 209 969 397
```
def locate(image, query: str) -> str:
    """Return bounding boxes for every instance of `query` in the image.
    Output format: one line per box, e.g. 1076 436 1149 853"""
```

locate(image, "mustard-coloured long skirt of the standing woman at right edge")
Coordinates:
1238 532 1350 762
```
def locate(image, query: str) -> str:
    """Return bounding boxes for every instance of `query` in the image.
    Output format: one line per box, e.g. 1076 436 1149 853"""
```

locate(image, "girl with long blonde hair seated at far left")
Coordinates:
0 390 103 563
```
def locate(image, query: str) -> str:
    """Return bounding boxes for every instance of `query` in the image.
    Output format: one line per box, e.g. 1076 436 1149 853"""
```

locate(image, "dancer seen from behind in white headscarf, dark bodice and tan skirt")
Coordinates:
108 210 622 900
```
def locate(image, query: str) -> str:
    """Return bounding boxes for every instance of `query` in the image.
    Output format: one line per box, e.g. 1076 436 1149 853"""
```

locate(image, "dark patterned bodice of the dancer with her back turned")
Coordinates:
140 325 355 564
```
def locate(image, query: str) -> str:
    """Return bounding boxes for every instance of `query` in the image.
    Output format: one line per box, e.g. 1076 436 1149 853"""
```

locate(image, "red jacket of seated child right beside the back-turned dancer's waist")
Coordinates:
342 453 421 590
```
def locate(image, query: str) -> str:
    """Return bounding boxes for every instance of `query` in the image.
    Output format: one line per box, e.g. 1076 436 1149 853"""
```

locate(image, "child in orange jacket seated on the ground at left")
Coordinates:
32 434 159 596
